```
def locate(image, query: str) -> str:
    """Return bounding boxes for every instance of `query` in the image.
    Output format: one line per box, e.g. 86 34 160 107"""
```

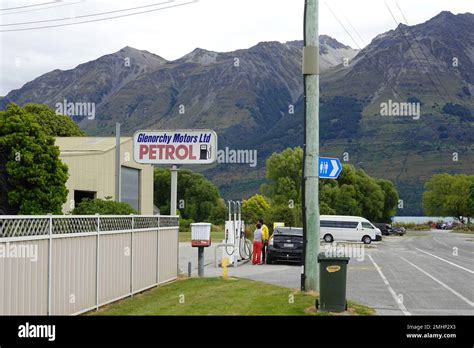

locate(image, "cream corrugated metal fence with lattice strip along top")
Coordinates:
0 216 179 315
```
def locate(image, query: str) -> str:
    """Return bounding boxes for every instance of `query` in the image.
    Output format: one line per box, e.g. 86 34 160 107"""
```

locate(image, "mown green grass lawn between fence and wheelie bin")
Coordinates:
88 278 375 315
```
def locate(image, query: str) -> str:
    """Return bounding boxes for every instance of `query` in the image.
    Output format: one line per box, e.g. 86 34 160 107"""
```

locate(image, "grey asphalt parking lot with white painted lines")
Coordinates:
180 230 474 315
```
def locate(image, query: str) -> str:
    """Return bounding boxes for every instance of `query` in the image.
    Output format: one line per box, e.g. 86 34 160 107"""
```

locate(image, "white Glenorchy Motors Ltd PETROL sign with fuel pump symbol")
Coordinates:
133 130 217 165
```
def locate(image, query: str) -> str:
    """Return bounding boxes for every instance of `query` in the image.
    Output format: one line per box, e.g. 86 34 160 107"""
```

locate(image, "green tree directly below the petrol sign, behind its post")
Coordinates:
154 168 225 221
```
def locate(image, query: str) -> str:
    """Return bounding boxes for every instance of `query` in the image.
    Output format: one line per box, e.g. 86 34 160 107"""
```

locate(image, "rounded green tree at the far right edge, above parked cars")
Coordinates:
423 173 474 220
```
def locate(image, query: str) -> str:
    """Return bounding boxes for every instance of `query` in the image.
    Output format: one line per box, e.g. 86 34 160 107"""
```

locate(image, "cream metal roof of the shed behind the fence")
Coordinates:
55 137 132 155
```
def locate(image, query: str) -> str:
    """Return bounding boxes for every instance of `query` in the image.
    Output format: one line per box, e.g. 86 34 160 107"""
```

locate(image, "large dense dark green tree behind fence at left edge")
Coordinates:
0 104 68 214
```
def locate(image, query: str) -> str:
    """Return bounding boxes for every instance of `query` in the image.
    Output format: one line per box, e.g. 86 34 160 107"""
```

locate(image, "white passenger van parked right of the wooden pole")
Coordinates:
320 215 382 244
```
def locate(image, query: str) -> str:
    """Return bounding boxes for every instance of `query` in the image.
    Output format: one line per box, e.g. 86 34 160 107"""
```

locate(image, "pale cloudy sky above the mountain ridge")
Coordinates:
0 0 474 95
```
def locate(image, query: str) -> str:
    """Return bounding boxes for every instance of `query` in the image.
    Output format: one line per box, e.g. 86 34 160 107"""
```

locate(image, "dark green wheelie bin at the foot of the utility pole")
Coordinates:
316 253 350 312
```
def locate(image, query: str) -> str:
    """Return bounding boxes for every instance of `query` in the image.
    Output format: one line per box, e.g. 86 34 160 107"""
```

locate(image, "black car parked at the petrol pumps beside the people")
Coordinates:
266 227 303 264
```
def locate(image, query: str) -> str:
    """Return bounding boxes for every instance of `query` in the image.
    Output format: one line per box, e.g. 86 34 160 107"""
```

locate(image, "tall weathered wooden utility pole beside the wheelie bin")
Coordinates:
301 0 320 291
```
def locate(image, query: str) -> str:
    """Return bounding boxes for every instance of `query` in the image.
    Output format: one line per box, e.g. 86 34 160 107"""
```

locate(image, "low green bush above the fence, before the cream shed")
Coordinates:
72 198 138 215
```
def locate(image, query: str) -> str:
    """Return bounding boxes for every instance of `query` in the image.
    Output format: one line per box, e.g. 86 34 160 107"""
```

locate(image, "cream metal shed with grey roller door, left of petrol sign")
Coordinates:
56 137 153 215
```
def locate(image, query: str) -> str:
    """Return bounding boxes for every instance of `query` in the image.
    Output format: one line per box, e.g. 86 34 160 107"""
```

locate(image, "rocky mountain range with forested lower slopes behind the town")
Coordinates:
0 12 474 215
